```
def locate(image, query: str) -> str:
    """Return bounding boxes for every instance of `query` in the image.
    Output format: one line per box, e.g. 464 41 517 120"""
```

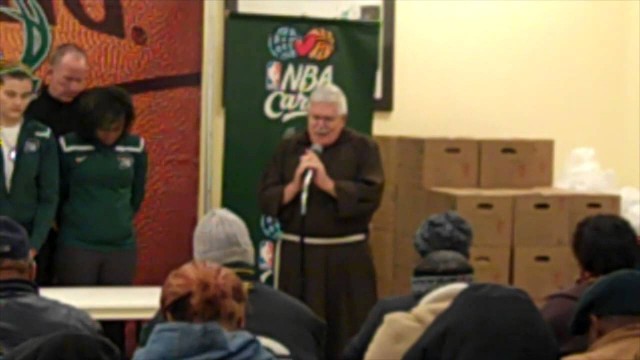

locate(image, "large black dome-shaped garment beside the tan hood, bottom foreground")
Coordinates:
404 284 558 360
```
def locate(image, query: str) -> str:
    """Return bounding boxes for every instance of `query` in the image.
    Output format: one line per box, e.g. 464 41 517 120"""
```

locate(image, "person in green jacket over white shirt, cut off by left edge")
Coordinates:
0 66 59 255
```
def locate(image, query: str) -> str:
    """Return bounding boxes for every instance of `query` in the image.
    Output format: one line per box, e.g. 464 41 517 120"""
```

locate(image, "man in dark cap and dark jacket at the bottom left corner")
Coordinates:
0 216 100 355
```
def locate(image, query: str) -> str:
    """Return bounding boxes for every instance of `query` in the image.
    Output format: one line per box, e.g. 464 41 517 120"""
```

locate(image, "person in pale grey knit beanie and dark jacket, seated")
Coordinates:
140 209 326 360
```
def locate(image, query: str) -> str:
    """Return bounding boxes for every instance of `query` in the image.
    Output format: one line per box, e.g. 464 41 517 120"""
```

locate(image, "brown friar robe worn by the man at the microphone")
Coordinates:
259 129 384 359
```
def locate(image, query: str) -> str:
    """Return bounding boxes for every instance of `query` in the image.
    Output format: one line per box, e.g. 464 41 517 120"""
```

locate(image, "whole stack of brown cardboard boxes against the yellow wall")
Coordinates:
371 137 620 302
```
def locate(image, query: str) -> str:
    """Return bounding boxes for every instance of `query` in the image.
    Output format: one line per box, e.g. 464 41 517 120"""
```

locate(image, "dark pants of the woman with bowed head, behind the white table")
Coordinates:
55 245 137 358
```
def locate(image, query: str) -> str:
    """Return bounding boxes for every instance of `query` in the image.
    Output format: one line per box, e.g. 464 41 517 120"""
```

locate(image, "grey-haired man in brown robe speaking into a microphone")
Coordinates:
260 85 384 359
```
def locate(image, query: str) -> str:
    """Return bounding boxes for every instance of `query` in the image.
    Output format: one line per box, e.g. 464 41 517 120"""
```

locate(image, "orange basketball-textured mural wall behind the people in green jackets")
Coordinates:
0 0 203 284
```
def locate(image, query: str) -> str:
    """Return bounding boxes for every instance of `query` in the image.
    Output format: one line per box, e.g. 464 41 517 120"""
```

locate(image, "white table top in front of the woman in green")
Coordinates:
40 286 161 320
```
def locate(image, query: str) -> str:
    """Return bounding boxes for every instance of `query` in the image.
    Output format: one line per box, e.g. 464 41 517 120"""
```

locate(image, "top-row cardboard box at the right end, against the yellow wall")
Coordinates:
480 140 553 188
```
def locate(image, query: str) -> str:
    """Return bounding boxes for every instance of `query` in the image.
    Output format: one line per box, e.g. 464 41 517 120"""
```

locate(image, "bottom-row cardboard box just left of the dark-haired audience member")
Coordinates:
513 247 579 302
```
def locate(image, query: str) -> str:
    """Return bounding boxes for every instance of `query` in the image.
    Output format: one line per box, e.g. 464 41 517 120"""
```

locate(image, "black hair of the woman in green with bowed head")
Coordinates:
77 86 135 140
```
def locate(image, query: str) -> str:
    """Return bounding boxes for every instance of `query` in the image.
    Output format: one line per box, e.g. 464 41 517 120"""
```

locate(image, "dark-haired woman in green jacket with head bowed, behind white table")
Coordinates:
56 87 147 286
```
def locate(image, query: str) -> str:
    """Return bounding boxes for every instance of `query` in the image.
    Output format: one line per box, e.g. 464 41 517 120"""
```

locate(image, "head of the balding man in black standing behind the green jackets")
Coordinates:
48 44 89 103
